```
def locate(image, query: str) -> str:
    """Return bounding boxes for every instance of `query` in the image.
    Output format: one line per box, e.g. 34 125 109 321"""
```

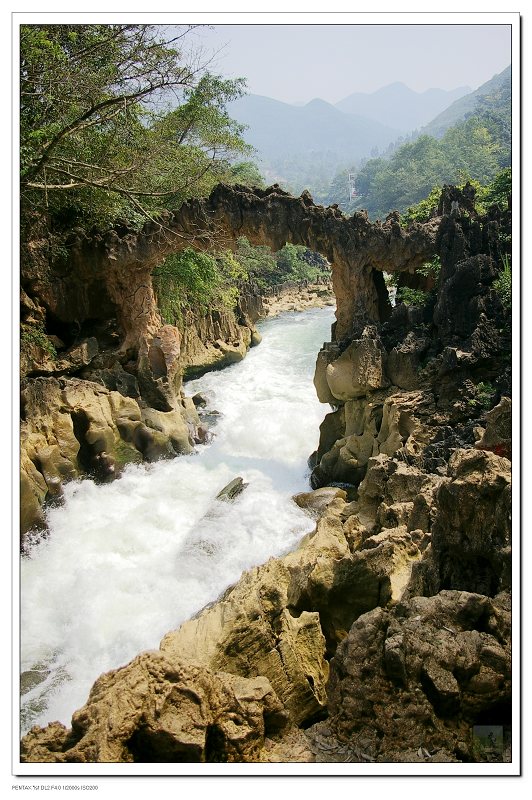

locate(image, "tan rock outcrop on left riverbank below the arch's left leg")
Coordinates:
20 377 199 533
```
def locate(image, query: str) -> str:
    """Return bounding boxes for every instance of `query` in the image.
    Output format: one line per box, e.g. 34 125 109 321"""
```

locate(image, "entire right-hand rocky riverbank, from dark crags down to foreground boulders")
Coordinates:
21 188 512 763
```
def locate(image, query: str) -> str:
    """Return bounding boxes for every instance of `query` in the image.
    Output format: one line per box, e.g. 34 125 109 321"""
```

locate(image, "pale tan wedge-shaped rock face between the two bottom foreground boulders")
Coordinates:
161 559 328 723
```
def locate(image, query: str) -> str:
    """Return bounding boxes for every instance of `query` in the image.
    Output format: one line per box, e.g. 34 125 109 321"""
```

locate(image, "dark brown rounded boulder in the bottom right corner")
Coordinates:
328 591 510 761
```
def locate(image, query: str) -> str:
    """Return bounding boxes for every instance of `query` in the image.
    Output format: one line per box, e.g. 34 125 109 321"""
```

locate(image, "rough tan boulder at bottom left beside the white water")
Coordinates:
21 651 287 763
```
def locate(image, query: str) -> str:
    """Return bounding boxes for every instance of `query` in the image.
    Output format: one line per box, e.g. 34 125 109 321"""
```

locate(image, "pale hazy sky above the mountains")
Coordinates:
191 25 511 103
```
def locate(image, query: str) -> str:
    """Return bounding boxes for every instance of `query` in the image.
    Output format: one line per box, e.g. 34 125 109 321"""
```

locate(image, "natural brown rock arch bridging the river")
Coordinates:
23 184 437 348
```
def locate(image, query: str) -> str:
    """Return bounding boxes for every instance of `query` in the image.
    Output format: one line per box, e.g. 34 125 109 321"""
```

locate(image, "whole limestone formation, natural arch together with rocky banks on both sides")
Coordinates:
22 187 511 763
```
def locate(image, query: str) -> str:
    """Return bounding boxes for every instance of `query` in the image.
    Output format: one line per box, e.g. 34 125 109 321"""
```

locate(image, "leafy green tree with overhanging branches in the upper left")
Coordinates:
20 24 249 224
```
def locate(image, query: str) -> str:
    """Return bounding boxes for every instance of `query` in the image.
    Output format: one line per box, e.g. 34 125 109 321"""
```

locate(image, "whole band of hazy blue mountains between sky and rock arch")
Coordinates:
229 67 511 206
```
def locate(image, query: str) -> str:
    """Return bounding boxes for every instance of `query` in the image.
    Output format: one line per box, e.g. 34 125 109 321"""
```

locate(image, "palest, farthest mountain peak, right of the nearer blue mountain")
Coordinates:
336 83 471 133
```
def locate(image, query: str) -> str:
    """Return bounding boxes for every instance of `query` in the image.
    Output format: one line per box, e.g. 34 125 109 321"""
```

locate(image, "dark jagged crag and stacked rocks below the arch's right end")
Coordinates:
312 187 511 488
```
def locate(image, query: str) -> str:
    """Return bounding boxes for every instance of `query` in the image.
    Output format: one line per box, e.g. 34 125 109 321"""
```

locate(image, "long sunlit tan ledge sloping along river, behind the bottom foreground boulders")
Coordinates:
161 484 432 708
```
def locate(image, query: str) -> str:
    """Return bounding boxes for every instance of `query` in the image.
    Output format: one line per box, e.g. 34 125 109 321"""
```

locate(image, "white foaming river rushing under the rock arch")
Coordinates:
21 307 333 731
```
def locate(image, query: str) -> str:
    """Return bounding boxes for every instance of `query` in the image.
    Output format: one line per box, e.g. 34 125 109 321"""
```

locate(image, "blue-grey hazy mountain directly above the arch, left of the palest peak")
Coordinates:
228 94 400 191
